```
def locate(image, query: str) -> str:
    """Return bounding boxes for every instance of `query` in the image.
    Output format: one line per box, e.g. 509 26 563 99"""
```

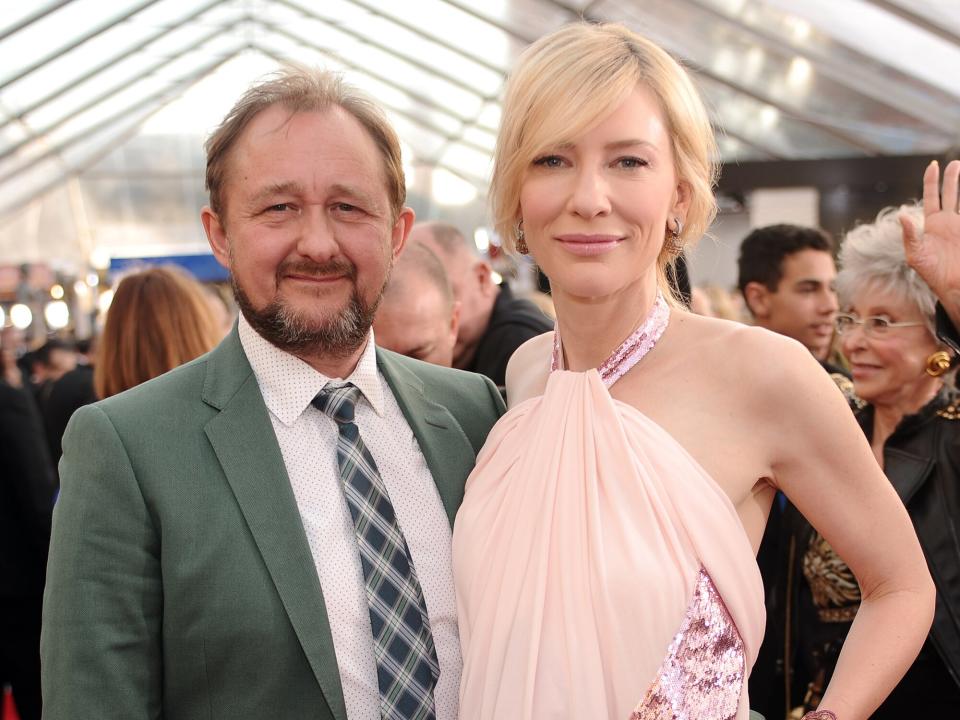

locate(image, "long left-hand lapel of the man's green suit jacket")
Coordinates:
203 327 347 720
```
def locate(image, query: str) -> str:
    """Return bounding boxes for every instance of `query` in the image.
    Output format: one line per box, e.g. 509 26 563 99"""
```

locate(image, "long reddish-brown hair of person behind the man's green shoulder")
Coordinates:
93 266 220 398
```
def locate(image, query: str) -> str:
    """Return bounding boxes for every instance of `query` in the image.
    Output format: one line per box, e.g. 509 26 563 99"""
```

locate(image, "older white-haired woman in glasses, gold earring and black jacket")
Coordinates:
800 204 960 719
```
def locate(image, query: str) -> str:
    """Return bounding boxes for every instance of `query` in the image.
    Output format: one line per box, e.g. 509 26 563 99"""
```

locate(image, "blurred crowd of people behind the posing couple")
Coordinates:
7 198 960 720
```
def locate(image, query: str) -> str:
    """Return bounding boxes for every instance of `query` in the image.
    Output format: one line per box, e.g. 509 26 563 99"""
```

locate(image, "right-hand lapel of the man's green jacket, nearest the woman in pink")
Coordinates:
377 348 476 526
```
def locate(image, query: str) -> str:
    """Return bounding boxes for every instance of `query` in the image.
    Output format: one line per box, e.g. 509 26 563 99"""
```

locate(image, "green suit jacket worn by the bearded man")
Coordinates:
41 328 503 720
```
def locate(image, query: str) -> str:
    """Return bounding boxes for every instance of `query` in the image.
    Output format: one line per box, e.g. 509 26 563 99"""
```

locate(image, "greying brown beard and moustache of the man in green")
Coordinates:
230 260 389 358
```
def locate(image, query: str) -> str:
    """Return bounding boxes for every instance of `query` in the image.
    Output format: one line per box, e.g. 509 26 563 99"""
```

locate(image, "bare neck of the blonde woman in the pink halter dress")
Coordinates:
553 279 657 372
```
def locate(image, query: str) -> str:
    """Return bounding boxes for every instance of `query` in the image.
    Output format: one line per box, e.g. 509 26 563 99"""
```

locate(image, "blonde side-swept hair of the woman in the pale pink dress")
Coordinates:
490 23 717 301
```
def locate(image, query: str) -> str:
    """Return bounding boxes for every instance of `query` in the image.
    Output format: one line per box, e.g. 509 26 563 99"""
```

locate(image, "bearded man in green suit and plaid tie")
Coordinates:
41 69 503 720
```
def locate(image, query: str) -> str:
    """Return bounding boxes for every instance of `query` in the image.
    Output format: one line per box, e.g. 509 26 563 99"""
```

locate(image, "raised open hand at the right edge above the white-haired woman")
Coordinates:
900 160 960 310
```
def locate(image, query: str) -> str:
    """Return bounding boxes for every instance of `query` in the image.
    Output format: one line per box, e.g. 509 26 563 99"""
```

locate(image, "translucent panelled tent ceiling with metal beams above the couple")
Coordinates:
0 0 960 266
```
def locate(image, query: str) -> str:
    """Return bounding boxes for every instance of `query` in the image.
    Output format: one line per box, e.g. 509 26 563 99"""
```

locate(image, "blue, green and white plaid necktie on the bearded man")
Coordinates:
313 383 440 720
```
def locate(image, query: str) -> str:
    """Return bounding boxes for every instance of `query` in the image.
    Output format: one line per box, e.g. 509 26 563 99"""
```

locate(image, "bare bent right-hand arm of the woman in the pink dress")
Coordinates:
757 344 934 720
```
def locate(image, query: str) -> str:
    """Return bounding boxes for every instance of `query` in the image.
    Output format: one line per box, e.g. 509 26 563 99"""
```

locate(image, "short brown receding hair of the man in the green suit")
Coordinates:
204 64 407 218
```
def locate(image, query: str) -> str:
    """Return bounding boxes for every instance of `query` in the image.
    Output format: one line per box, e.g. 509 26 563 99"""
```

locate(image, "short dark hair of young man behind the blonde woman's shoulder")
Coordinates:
737 224 833 293
